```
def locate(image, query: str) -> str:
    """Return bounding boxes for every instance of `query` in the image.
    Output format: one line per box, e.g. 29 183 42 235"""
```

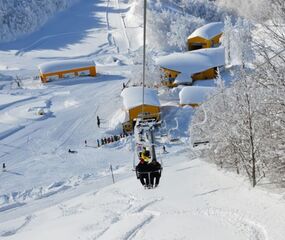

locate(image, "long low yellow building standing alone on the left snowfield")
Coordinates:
38 60 96 83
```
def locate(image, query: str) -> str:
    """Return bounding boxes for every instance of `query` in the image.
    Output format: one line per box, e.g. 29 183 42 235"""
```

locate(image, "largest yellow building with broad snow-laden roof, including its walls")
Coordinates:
157 47 225 87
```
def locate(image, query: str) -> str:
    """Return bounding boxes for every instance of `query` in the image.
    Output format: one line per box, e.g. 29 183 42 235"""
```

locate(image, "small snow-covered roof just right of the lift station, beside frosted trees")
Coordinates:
179 86 215 105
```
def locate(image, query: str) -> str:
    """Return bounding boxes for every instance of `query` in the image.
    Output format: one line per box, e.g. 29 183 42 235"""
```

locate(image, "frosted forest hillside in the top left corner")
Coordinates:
0 0 78 42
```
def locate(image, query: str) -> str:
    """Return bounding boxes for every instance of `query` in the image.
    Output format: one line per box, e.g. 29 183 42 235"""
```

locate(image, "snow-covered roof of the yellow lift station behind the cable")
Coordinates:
121 87 160 110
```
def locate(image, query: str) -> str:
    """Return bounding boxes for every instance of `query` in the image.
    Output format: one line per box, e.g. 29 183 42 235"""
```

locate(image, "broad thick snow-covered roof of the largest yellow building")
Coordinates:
157 47 225 77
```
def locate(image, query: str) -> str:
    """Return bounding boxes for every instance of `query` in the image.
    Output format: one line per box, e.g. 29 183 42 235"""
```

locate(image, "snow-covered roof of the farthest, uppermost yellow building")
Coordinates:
188 22 224 40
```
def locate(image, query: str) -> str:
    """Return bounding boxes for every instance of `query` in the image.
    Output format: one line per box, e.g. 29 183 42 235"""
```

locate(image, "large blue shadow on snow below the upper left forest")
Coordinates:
0 0 117 54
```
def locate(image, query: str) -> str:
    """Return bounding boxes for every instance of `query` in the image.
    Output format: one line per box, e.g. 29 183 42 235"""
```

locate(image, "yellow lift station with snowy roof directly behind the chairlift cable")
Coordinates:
121 87 160 131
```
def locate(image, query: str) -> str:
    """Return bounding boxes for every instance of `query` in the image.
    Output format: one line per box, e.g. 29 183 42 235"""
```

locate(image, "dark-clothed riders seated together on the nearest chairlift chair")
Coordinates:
136 147 162 188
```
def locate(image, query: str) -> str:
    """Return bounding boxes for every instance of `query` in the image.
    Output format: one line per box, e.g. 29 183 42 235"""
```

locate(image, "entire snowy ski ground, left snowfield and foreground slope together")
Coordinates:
0 0 285 240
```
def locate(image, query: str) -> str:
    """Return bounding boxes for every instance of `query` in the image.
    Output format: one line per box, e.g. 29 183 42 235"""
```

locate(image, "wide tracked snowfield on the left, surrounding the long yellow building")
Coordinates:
0 0 136 209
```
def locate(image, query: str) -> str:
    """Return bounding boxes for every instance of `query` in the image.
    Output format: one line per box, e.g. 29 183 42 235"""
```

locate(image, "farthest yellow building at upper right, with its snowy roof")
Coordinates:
187 22 224 51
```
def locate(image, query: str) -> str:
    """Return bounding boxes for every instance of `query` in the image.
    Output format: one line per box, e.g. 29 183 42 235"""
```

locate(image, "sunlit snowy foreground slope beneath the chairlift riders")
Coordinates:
0 148 285 240
